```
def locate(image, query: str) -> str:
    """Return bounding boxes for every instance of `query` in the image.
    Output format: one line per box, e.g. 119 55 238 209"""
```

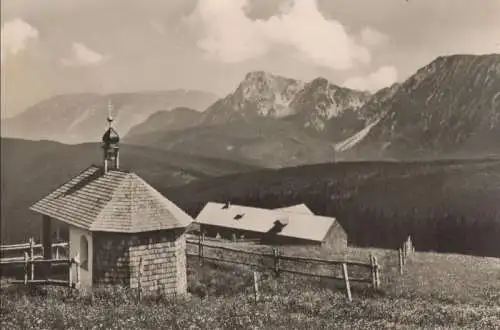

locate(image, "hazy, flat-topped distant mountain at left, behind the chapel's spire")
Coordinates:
2 90 217 143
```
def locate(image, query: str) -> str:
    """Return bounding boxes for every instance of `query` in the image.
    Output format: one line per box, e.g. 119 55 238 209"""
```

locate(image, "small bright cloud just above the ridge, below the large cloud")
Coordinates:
343 66 398 92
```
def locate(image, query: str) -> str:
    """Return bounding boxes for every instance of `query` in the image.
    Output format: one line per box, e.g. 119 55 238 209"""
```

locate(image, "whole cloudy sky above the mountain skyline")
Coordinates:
1 0 500 118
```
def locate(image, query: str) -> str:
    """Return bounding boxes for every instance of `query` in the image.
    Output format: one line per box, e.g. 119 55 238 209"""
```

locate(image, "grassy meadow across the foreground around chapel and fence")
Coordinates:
0 249 500 329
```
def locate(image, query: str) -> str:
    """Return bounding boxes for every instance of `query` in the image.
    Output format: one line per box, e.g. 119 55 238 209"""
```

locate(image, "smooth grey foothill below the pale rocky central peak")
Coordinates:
125 118 335 168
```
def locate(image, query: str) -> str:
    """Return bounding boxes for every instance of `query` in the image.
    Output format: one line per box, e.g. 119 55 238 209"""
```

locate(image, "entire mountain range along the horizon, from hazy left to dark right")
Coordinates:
0 54 500 167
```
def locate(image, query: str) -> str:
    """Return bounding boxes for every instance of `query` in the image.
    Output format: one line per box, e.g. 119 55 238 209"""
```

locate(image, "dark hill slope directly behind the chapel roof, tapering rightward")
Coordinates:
1 139 256 242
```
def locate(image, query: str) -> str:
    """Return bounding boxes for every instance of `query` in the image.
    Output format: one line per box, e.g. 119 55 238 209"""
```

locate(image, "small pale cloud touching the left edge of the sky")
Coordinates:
1 18 39 62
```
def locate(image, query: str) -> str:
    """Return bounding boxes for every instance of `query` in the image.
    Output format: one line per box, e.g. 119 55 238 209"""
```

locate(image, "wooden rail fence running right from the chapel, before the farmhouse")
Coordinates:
187 236 380 301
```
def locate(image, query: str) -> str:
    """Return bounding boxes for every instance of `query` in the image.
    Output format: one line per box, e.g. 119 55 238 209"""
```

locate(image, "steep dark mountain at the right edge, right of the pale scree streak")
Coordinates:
342 54 500 159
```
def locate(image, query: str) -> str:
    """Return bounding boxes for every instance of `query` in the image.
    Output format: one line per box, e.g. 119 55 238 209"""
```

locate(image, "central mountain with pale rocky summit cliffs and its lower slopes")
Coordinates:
125 71 370 168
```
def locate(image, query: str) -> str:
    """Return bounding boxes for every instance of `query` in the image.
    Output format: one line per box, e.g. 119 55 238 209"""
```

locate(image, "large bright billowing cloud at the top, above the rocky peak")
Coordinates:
189 0 371 70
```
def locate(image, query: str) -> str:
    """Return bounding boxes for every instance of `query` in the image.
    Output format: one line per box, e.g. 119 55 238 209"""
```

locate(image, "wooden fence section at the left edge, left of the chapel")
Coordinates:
0 238 80 288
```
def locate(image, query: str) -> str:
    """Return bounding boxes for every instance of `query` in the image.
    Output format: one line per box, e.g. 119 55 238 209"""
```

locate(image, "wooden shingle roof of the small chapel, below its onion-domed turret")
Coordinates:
30 166 193 233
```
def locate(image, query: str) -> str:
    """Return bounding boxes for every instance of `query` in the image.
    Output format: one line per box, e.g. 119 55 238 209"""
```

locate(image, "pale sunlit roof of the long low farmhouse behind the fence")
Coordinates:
196 202 335 242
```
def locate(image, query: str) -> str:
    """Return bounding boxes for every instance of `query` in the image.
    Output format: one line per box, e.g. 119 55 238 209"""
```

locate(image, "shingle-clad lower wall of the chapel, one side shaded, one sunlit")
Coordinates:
94 229 187 295
